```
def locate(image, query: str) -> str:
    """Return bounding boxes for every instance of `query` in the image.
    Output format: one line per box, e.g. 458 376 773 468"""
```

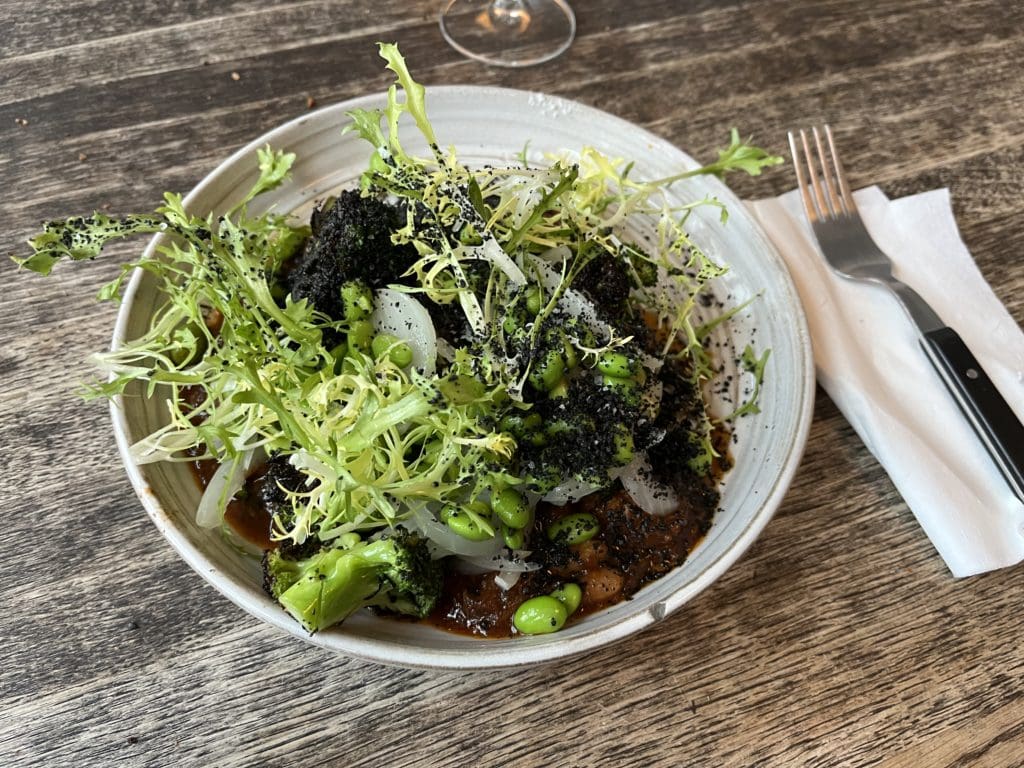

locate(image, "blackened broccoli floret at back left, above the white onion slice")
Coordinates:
288 189 417 319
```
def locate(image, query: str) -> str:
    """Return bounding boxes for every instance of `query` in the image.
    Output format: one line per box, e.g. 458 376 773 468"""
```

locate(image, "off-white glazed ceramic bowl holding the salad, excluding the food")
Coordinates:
113 86 814 669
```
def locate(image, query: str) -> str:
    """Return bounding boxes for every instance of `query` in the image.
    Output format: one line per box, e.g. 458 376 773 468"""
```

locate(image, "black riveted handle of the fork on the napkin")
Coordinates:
921 328 1024 502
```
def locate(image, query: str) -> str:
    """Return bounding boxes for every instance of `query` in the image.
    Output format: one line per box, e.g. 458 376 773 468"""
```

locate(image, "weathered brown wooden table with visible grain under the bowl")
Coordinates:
0 0 1024 768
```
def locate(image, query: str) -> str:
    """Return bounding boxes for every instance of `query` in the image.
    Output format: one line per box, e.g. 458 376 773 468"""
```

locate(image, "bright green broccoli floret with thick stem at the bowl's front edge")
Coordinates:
263 528 442 633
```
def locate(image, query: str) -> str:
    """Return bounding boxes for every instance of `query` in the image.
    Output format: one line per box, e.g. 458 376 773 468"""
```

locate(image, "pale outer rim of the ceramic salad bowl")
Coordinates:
110 85 815 671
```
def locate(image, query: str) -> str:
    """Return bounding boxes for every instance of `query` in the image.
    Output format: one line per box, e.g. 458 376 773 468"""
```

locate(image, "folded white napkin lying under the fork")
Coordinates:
749 187 1024 577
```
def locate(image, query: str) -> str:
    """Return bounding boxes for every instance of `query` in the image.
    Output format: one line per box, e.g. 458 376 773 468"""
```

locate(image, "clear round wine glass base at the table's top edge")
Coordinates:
440 0 575 67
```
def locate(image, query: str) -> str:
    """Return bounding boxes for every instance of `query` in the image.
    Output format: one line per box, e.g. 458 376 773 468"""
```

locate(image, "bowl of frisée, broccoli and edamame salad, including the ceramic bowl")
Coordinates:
16 45 814 669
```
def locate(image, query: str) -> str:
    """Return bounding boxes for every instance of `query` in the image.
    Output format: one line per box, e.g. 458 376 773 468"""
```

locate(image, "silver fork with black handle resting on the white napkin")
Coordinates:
790 126 1024 501
